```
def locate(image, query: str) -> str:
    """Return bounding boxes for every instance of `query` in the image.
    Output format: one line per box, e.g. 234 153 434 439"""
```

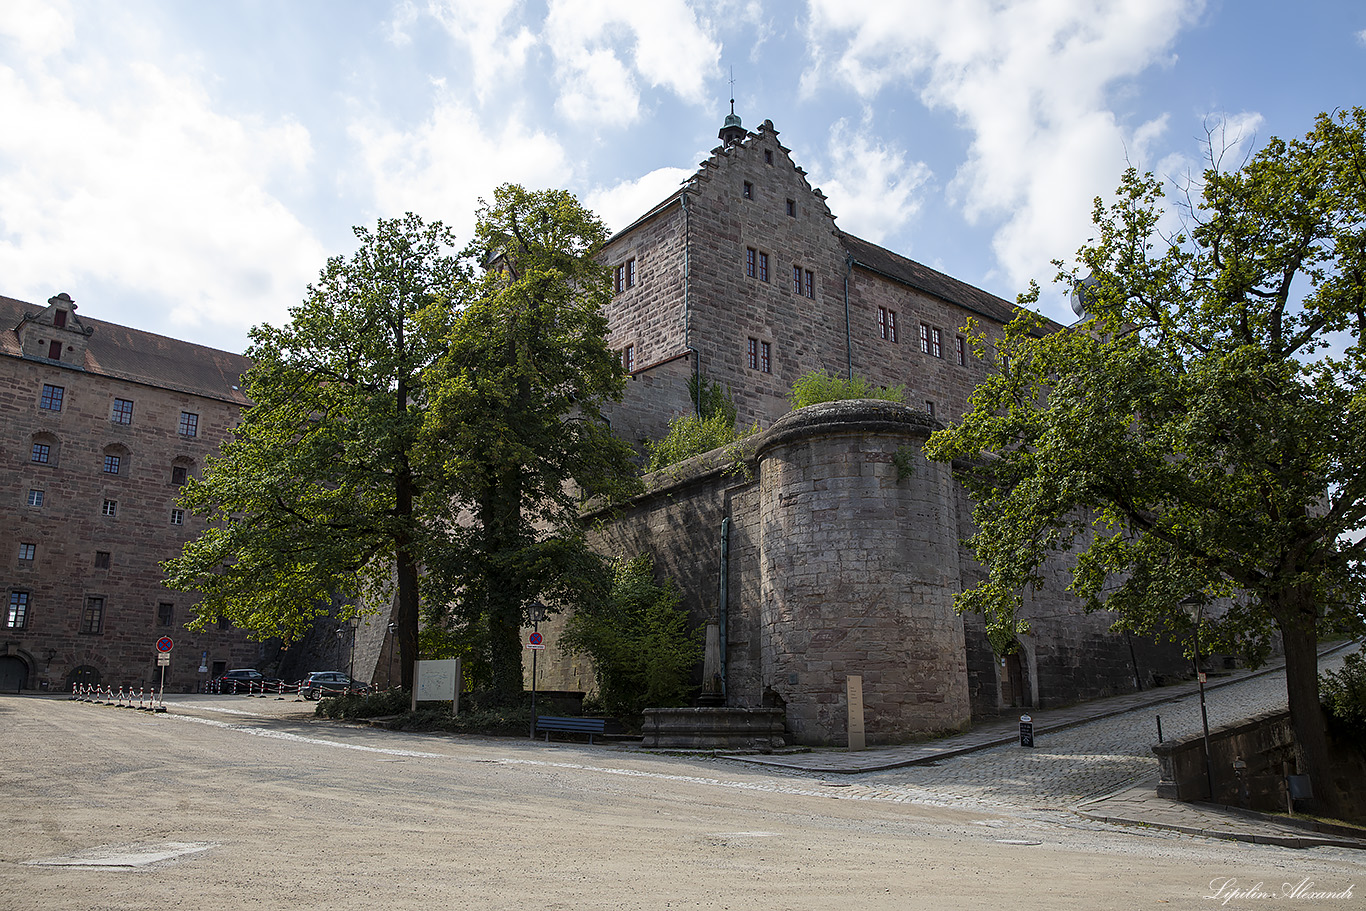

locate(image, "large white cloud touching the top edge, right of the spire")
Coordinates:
803 0 1203 287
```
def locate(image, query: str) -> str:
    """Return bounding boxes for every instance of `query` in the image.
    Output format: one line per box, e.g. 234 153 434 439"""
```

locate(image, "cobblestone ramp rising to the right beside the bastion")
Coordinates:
726 651 1344 811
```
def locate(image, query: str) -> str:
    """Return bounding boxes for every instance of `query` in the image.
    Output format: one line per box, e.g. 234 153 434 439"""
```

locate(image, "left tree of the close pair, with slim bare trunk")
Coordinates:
164 213 466 687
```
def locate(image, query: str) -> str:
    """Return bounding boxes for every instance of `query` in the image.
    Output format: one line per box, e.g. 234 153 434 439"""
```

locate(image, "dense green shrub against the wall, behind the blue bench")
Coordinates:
560 555 702 718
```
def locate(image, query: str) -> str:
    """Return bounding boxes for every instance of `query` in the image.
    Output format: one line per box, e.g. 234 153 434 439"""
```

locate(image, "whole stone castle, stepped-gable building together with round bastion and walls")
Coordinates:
527 113 1182 744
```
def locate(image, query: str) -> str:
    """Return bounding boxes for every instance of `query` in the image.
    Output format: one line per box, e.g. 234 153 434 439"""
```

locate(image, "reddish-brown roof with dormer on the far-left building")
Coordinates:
0 296 251 406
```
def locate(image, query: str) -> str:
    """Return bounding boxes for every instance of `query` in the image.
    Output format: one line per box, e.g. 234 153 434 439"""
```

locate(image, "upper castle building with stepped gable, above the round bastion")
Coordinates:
604 113 1032 450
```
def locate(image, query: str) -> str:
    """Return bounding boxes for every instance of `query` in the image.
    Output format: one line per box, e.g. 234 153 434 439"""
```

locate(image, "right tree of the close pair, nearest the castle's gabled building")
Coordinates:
423 186 637 699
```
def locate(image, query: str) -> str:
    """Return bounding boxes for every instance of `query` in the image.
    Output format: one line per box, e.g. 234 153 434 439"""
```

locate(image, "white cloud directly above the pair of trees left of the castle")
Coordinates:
350 96 572 238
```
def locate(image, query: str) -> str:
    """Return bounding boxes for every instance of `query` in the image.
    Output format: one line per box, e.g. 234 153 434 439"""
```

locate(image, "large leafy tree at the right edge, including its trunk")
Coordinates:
928 108 1366 806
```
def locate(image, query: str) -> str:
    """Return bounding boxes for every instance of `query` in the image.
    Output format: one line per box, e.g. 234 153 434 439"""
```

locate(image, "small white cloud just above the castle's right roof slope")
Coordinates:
821 120 930 243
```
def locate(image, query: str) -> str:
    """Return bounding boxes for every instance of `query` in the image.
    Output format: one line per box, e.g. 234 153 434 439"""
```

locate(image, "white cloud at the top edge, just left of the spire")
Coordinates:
544 0 721 124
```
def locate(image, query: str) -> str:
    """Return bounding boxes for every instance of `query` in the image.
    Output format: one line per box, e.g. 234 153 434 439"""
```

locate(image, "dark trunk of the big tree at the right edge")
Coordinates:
1273 591 1341 815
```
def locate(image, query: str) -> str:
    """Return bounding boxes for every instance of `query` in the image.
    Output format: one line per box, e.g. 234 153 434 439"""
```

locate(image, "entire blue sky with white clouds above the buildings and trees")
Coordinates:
0 0 1366 351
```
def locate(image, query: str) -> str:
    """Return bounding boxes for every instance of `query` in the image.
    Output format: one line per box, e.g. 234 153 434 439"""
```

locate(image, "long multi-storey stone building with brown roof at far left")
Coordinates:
0 294 260 691
